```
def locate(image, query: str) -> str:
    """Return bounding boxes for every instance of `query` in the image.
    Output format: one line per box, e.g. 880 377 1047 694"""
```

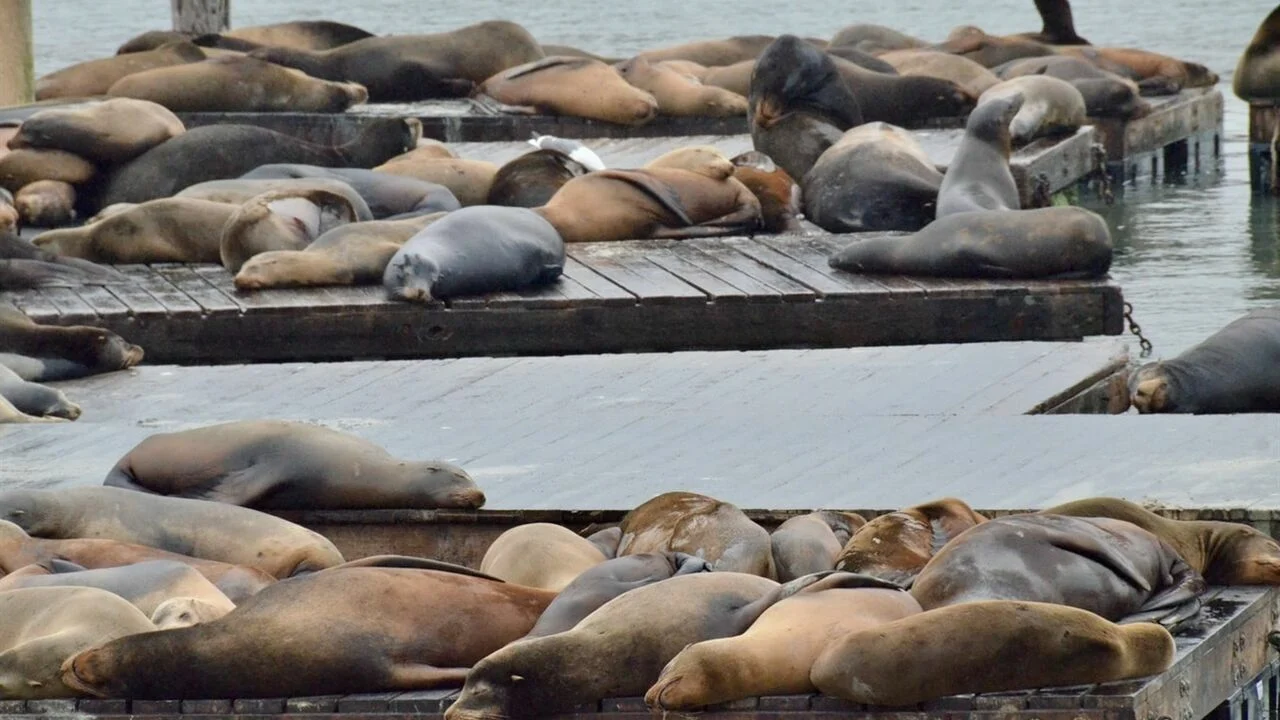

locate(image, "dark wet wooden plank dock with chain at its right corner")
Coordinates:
0 234 1124 364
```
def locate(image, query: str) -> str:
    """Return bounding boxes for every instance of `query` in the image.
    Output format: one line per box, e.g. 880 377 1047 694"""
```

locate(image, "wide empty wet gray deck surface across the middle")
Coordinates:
0 341 1280 510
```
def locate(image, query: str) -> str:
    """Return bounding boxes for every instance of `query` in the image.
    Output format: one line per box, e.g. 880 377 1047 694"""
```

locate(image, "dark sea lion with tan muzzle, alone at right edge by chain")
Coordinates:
1129 306 1280 415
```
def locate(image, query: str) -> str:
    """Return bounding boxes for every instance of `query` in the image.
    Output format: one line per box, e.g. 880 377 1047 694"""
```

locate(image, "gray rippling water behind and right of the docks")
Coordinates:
33 0 1280 357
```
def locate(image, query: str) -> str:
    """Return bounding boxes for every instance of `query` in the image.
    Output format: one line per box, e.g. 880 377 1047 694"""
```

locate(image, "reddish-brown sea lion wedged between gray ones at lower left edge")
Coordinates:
0 520 275 602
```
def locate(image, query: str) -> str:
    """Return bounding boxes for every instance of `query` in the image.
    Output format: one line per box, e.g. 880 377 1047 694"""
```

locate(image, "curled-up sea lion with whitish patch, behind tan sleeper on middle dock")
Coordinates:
218 190 357 273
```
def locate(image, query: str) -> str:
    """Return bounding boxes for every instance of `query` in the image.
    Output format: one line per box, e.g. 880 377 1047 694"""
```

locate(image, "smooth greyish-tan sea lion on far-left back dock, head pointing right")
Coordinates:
106 55 369 113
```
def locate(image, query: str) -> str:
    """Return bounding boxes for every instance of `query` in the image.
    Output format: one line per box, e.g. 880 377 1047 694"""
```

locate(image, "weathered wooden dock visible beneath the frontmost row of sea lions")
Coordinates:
0 588 1280 720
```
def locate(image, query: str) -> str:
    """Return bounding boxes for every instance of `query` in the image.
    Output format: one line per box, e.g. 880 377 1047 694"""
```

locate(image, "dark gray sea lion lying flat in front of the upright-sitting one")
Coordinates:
831 208 1112 279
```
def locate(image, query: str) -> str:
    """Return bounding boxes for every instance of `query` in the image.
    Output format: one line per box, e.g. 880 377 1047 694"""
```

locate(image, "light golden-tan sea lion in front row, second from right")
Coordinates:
644 574 920 711
